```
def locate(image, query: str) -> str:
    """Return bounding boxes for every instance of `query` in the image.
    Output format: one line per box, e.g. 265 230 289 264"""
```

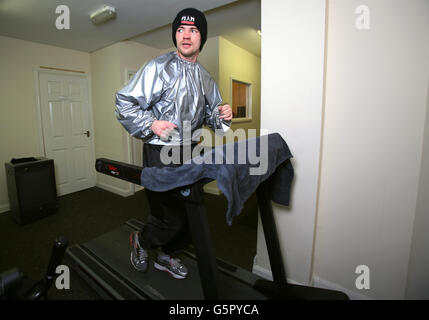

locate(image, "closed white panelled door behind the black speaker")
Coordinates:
39 72 95 195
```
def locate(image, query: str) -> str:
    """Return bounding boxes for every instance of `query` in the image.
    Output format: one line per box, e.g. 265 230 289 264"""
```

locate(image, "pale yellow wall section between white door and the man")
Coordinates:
91 41 161 196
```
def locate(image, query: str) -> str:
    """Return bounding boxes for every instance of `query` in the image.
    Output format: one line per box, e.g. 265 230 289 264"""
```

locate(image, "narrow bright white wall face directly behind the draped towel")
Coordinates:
254 0 325 283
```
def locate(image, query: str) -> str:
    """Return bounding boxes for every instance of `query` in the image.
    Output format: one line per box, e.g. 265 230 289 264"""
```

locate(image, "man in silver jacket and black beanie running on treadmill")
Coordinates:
115 8 232 279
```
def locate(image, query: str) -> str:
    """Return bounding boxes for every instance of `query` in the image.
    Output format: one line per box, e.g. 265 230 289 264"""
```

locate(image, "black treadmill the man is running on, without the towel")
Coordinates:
64 158 348 300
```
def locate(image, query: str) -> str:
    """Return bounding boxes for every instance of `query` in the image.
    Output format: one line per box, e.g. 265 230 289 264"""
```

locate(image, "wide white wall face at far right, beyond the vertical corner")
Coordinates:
310 0 429 299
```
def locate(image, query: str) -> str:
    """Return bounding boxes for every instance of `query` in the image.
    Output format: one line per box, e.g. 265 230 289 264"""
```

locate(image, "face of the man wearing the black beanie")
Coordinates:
176 25 201 61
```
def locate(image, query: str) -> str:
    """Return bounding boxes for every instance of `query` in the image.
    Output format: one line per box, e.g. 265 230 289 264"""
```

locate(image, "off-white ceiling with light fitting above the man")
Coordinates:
0 0 261 56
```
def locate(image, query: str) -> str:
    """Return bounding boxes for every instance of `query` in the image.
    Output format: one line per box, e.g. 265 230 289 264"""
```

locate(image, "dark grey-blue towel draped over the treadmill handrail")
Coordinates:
141 133 294 225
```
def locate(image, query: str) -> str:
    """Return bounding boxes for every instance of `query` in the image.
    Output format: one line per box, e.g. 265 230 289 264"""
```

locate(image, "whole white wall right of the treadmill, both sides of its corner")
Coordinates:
254 0 429 299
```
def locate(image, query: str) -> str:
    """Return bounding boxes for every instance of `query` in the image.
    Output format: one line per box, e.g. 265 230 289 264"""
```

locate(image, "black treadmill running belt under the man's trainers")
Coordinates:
68 224 266 300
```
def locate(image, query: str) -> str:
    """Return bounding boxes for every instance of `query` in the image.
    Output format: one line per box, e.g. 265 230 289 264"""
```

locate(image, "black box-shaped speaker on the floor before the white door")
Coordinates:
5 158 57 225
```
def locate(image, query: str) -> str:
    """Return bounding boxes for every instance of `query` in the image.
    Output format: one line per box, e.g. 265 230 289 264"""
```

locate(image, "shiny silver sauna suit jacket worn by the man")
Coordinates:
115 52 231 145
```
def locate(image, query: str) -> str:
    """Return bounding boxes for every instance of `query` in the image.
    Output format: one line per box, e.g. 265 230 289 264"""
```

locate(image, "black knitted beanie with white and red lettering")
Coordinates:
172 8 207 51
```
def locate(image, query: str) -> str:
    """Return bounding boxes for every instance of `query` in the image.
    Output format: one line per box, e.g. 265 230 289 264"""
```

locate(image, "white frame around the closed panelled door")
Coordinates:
33 66 97 187
